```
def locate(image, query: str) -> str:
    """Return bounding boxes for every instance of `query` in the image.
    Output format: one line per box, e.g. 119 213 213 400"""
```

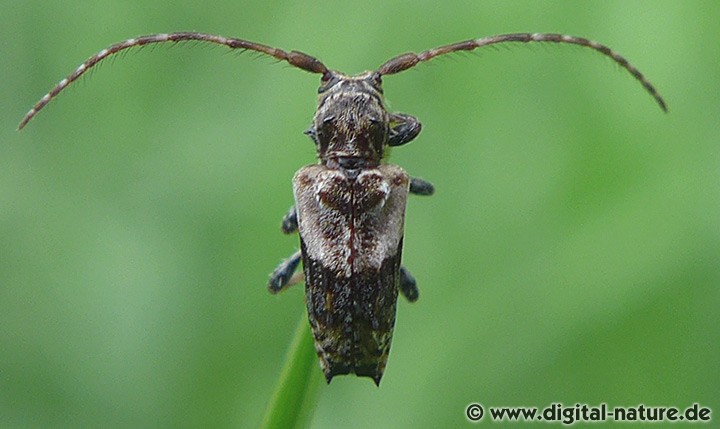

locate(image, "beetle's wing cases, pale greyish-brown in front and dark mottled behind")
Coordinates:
295 165 409 383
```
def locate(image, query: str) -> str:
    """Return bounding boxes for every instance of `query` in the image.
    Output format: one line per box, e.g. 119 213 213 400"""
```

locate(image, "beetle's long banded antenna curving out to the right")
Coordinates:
378 33 667 112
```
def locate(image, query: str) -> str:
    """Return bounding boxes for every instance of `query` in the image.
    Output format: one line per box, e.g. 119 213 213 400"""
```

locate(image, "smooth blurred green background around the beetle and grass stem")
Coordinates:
0 0 720 428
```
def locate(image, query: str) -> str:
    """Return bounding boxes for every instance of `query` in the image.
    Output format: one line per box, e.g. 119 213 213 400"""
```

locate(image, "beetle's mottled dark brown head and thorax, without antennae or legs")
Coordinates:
310 72 389 169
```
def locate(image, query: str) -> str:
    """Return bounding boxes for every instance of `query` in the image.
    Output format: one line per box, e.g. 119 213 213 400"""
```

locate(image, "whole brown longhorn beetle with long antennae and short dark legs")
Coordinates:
18 32 667 385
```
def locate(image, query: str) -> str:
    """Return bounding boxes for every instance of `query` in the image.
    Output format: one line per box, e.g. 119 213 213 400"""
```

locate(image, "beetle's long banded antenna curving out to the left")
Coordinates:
18 32 328 130
